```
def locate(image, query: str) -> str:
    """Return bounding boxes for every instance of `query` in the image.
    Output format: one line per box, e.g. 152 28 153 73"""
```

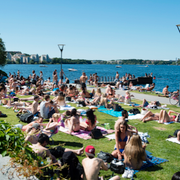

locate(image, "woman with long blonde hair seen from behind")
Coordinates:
124 135 146 170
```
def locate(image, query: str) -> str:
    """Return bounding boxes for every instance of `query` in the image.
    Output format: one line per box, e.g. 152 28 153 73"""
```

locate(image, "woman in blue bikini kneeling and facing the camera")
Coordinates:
112 121 130 160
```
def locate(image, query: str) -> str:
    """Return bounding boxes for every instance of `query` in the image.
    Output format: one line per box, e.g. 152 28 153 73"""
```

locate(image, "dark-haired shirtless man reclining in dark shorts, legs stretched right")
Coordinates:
30 134 84 163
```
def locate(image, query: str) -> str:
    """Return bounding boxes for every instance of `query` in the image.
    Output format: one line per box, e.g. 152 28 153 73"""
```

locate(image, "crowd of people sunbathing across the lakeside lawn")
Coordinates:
0 70 180 180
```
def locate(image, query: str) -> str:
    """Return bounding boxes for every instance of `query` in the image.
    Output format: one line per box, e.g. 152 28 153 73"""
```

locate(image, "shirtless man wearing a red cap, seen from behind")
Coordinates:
82 146 120 180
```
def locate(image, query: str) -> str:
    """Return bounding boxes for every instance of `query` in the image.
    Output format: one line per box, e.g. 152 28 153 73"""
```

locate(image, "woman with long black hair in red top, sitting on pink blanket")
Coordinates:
80 109 97 131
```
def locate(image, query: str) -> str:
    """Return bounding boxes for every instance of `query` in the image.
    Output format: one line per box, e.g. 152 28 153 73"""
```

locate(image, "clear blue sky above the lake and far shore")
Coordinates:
0 0 180 60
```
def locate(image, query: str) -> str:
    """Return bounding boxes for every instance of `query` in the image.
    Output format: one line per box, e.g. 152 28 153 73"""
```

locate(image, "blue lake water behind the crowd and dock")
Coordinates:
2 64 180 91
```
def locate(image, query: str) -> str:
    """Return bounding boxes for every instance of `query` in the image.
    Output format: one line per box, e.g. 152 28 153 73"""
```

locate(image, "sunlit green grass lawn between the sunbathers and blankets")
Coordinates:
0 95 180 180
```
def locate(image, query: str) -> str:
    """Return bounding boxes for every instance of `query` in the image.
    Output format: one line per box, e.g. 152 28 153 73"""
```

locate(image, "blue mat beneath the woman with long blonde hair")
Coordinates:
129 151 168 174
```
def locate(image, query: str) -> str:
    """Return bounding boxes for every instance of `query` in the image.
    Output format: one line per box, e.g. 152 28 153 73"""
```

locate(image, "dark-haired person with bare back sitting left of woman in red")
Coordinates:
65 108 80 134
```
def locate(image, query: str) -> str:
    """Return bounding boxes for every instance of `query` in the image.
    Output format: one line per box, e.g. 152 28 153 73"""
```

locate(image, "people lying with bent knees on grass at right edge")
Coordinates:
140 110 179 123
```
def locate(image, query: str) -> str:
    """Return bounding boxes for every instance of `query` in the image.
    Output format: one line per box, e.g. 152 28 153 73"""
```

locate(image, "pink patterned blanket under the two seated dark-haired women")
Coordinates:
59 126 114 140
